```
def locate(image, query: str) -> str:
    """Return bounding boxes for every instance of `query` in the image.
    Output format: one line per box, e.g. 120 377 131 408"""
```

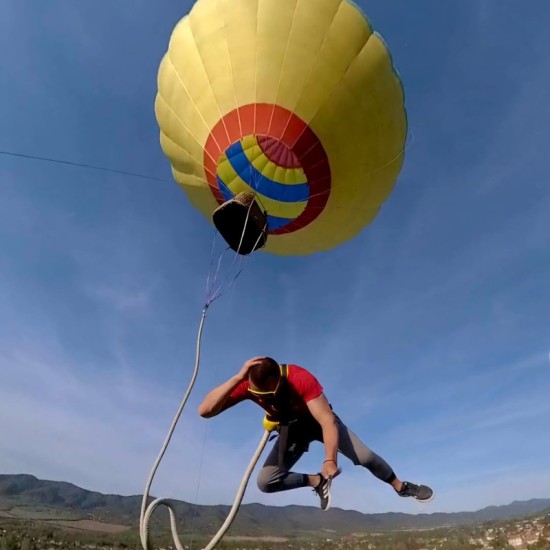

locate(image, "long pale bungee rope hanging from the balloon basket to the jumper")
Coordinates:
139 218 269 550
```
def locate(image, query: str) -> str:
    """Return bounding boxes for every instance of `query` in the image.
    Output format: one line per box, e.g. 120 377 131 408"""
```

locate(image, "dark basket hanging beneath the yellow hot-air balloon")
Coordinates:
212 192 268 256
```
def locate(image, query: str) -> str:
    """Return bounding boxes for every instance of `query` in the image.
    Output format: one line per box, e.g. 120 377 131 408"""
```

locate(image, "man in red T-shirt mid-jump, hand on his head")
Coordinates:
199 357 433 510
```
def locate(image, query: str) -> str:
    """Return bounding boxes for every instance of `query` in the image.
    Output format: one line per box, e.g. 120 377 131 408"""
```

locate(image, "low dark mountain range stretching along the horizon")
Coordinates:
0 474 550 536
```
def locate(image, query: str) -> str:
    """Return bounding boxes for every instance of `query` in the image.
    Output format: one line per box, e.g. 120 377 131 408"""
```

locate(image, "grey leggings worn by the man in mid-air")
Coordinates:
257 415 395 493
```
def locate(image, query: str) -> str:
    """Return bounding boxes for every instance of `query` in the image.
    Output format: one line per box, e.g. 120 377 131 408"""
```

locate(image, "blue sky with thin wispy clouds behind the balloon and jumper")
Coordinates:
0 0 550 513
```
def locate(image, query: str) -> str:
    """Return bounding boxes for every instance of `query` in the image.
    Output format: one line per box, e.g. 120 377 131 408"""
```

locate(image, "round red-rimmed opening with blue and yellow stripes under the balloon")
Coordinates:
204 103 332 242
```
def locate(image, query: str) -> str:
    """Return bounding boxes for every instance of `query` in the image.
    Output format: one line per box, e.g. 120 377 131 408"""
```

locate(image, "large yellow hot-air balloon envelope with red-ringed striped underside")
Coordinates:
155 0 407 254
